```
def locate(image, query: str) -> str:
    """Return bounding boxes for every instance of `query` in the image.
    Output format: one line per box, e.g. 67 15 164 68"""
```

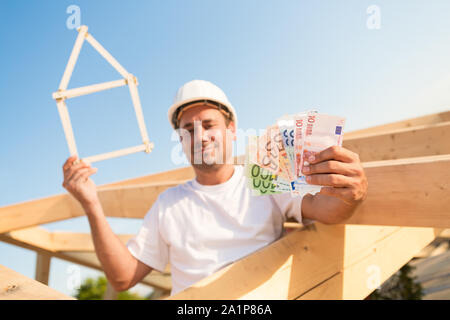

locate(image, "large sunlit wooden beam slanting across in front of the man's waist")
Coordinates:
170 223 439 300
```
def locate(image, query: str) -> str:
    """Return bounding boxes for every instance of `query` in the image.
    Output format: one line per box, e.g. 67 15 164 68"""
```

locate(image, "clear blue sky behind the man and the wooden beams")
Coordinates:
0 0 450 293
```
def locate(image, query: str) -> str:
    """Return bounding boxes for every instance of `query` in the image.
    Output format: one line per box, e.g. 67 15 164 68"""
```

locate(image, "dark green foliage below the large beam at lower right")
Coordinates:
367 264 423 300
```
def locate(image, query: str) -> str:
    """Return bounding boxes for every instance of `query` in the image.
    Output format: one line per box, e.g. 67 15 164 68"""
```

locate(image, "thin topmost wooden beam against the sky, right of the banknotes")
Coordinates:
344 111 450 139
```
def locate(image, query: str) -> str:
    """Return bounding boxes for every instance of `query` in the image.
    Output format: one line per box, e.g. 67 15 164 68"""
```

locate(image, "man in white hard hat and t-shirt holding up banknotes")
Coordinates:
63 80 367 294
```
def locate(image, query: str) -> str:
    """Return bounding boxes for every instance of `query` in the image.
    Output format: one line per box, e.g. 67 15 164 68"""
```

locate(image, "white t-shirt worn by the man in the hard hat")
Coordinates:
127 166 302 294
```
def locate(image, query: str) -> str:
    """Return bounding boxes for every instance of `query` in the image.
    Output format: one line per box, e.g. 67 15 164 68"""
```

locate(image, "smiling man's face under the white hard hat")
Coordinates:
180 104 236 169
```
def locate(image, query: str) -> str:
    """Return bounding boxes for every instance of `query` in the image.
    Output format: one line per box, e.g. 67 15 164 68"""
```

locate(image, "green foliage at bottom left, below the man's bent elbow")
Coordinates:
75 276 146 300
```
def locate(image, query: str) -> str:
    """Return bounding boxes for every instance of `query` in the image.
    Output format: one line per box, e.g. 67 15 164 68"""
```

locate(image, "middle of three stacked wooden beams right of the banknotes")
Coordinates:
343 121 450 162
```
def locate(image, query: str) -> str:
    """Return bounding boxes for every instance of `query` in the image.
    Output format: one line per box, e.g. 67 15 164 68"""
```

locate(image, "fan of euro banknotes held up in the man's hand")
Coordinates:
245 111 345 197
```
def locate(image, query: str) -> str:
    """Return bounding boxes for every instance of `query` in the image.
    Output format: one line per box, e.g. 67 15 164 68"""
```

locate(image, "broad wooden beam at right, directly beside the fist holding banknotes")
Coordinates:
345 155 450 228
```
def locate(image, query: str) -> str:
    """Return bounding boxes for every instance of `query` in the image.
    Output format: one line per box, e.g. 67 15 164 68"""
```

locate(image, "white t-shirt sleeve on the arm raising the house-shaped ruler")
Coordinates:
127 198 169 272
